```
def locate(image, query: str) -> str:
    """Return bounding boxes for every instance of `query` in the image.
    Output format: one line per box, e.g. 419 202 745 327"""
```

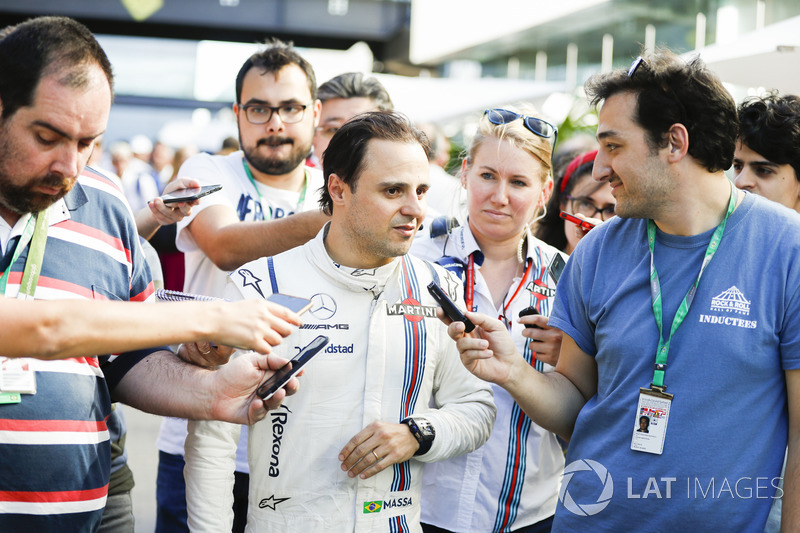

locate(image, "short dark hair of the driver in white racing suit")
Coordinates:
319 111 430 216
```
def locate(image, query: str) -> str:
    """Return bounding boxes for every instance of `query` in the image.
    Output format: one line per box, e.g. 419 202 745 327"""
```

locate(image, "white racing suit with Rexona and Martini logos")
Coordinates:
185 228 495 533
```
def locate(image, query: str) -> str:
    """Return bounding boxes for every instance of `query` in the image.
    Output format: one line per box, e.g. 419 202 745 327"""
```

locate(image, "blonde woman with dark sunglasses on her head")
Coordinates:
412 108 564 533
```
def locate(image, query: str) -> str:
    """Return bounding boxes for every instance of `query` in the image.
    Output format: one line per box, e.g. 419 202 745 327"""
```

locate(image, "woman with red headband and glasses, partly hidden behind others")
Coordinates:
536 150 617 254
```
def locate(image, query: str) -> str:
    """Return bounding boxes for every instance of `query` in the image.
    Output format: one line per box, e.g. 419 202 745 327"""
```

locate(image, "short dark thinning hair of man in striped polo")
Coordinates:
0 17 114 119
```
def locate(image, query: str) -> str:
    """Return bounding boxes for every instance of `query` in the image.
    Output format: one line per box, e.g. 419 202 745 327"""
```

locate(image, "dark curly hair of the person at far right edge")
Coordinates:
739 91 800 181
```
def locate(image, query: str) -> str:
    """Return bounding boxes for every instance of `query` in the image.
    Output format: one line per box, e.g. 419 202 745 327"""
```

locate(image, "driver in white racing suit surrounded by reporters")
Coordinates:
185 112 495 533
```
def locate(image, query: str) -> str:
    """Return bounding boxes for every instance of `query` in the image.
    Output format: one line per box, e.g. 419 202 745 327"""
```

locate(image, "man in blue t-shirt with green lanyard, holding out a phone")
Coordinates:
450 47 800 532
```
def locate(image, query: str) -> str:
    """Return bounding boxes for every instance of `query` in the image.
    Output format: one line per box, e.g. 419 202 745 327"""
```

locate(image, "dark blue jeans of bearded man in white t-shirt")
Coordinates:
156 451 250 533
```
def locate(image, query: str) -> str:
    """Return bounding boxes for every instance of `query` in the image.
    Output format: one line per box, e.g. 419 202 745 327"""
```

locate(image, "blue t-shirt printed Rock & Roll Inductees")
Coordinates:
550 194 800 532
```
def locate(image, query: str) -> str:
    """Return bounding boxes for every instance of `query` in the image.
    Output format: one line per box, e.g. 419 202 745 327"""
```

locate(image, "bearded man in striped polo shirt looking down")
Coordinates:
0 17 296 531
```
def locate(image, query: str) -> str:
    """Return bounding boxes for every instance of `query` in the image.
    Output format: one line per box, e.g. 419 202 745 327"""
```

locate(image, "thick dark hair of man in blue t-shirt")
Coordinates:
586 49 738 172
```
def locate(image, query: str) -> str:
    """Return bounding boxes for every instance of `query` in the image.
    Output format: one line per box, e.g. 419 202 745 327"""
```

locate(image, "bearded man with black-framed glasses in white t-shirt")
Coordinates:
156 39 327 533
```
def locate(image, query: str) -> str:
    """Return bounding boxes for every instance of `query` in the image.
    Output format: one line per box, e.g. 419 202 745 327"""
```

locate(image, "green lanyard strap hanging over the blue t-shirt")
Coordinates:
647 183 736 391
